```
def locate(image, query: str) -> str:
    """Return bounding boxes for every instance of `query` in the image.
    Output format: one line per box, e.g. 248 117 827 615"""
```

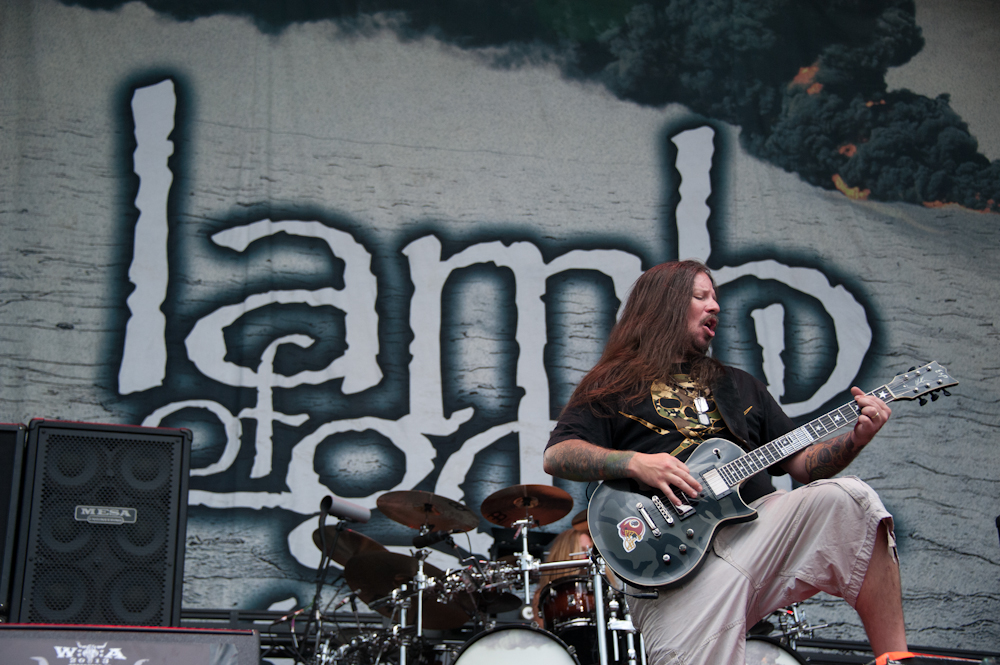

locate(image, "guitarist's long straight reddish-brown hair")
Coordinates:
566 261 722 413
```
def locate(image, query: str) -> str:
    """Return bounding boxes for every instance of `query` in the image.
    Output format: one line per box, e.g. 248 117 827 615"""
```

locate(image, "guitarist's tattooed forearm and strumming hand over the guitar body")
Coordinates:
543 439 701 505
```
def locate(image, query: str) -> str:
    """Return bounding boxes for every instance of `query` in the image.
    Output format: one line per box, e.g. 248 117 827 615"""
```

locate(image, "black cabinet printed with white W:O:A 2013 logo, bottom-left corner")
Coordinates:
0 624 260 665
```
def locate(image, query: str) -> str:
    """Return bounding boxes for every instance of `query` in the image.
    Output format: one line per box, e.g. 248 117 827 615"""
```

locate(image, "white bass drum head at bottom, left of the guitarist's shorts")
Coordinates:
454 625 580 665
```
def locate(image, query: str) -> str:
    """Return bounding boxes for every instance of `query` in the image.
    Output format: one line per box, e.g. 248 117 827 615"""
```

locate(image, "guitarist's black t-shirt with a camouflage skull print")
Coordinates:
546 367 795 503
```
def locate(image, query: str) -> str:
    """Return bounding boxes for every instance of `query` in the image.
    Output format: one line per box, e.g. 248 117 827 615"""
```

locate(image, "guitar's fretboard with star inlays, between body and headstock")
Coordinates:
718 386 896 487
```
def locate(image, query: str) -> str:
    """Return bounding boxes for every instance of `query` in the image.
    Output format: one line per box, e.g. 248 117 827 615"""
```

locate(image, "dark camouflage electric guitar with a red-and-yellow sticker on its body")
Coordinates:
587 362 958 587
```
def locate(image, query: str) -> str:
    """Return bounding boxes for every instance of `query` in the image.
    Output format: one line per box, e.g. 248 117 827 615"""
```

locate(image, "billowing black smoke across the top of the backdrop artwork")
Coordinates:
76 0 1000 212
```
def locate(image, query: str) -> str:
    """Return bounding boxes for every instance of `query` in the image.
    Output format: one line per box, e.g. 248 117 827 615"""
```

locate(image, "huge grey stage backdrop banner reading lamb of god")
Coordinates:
0 0 1000 649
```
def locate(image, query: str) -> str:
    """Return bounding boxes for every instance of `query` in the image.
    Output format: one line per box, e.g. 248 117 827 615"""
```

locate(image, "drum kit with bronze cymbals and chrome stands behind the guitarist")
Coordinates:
303 485 645 665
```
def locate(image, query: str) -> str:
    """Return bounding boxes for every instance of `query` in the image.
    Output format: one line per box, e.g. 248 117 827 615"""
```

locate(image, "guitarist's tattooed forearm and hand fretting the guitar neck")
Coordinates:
782 388 892 483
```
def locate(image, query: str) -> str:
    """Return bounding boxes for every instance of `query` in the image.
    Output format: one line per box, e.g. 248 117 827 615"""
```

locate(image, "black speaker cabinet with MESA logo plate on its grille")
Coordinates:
11 420 191 626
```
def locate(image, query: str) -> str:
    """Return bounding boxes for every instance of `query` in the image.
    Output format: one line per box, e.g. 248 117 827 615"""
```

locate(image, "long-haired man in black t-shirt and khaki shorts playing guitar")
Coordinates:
544 261 906 665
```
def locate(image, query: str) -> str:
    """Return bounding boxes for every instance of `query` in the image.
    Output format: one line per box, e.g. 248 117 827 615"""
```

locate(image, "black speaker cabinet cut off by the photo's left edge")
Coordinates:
0 423 25 620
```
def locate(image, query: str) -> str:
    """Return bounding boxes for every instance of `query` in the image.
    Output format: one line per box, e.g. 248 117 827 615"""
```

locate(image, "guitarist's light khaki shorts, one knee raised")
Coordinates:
628 476 896 665
